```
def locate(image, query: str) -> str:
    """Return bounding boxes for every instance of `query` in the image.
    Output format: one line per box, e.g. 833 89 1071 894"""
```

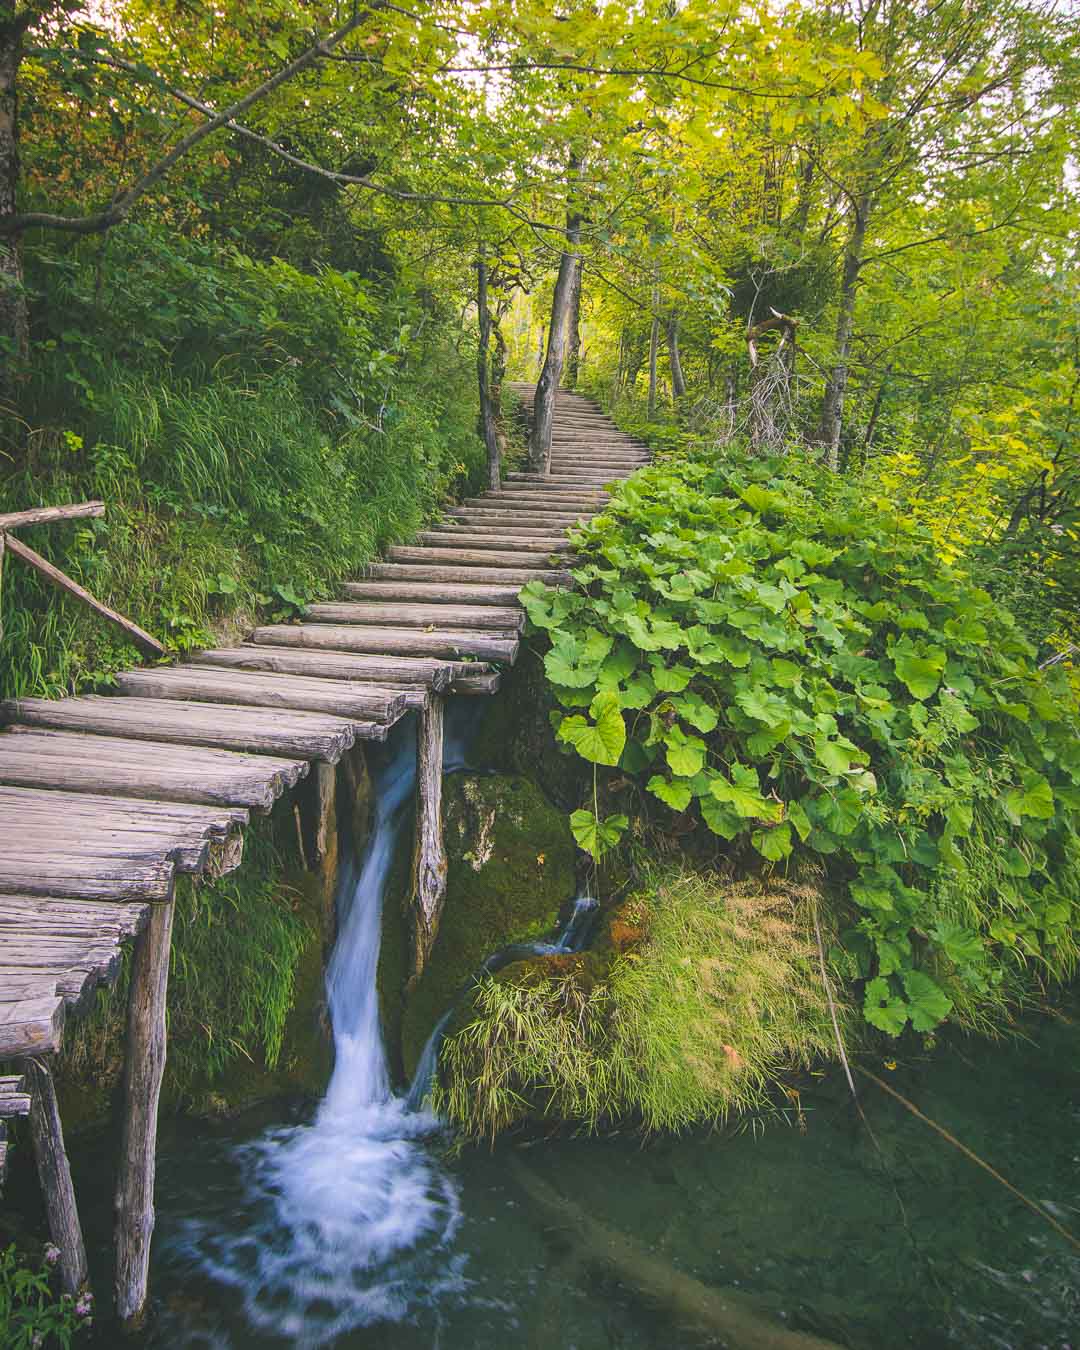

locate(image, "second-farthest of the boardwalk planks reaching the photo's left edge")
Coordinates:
0 726 308 810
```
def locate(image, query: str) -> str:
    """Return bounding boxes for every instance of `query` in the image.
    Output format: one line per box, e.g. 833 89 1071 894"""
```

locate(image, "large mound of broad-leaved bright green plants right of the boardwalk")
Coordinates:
522 452 1080 1035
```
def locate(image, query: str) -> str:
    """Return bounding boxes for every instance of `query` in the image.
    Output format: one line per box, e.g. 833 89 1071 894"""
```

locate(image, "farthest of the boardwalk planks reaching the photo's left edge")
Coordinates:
0 694 356 764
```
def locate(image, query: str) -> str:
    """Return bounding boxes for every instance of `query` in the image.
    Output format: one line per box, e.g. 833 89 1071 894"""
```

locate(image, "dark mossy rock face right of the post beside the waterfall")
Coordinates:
401 774 575 1073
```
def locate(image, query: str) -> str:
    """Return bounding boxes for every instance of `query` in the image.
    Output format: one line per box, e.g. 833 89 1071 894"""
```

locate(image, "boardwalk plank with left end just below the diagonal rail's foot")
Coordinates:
116 664 404 722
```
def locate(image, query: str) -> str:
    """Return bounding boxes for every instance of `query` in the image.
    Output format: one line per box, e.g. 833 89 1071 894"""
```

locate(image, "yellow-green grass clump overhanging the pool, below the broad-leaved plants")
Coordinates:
436 873 849 1138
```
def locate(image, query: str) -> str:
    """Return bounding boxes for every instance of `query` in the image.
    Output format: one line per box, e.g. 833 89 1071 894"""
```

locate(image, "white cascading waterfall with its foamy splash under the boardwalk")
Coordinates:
169 705 595 1346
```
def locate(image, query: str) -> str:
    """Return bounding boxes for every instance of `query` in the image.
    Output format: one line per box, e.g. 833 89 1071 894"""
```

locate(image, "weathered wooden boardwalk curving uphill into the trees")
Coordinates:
0 385 647 1317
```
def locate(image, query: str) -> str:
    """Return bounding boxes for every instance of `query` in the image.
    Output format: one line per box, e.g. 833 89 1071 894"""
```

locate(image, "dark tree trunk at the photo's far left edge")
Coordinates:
0 0 30 401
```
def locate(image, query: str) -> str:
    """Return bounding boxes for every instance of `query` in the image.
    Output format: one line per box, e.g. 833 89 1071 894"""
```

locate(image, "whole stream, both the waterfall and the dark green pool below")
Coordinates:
63 726 1080 1350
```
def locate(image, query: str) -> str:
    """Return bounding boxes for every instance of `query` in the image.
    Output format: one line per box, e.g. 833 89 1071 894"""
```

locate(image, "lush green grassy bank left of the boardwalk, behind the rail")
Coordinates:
0 225 482 695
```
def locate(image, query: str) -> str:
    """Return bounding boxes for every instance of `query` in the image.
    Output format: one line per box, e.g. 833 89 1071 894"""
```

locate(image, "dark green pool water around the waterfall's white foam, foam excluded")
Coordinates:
63 999 1080 1350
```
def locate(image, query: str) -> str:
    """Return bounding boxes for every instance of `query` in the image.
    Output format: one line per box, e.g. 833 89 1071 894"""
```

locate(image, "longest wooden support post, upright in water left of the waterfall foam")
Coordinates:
113 900 173 1331
